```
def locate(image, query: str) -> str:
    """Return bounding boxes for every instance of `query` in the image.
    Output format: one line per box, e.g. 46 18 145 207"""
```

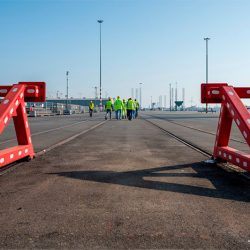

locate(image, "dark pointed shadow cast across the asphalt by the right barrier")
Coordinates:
49 162 250 202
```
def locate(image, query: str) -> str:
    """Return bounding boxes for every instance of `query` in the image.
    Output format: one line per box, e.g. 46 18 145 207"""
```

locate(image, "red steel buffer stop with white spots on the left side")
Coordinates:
0 82 46 168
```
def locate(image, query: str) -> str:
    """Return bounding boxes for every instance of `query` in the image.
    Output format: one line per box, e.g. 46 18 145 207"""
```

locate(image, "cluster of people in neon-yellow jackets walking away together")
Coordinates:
105 96 140 121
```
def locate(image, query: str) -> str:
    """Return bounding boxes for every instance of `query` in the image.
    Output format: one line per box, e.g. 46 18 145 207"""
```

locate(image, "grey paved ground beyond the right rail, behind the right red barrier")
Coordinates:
142 111 250 154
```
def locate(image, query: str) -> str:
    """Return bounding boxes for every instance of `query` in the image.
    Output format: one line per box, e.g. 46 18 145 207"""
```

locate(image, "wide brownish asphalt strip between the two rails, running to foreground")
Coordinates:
0 116 250 249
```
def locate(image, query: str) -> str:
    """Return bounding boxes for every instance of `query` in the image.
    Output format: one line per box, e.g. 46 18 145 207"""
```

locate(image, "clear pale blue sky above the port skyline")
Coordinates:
0 0 250 106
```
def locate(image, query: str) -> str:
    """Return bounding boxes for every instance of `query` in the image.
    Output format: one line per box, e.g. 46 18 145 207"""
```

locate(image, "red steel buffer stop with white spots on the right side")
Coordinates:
201 83 250 171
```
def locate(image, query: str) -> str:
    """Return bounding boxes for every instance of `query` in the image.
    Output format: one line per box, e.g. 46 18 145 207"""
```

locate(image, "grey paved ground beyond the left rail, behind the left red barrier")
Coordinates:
0 114 104 152
